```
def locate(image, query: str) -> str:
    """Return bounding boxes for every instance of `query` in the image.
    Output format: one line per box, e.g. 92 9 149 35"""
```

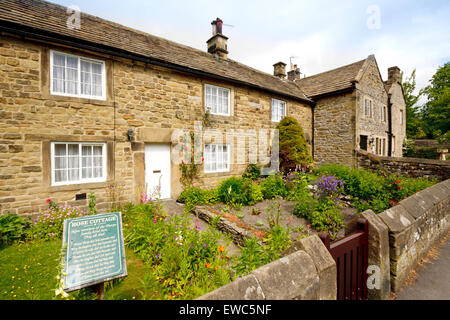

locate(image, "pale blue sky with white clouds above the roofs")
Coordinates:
50 0 450 104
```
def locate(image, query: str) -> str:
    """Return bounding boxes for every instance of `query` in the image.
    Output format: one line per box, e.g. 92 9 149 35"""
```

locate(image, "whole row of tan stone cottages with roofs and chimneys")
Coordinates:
0 0 405 215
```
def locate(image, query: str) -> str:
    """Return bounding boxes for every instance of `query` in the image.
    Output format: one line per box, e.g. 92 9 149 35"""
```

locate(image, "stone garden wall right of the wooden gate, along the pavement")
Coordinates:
378 180 450 292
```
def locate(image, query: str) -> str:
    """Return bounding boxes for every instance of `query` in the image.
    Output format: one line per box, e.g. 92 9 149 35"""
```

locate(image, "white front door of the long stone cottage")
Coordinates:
145 144 171 199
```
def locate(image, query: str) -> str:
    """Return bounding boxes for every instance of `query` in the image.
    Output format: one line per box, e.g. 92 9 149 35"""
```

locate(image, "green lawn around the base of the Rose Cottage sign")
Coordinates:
0 239 161 300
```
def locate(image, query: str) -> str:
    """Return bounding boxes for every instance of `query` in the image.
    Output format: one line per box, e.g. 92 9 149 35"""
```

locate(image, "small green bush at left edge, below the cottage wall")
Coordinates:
0 213 28 248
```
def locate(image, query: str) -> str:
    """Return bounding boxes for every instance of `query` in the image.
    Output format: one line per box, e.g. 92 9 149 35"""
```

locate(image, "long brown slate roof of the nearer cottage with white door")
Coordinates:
0 0 313 103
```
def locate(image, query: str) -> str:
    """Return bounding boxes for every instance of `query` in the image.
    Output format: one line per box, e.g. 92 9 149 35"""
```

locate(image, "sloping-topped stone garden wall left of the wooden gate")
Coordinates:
198 235 337 300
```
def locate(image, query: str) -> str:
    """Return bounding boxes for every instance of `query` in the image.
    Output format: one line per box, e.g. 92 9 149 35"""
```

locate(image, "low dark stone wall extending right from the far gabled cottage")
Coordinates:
357 150 450 181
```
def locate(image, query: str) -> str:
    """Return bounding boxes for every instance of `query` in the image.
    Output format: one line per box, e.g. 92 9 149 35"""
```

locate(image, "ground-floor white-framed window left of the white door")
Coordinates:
51 142 106 186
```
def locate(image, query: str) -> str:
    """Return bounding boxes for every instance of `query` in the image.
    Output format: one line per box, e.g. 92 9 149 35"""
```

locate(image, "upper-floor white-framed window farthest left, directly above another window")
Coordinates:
50 50 106 100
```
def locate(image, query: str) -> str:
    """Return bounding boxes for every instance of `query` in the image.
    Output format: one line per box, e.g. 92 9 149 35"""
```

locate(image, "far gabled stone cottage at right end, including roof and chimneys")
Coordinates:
296 55 406 166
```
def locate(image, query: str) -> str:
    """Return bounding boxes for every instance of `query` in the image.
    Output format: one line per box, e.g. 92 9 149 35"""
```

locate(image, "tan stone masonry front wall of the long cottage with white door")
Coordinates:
0 35 312 215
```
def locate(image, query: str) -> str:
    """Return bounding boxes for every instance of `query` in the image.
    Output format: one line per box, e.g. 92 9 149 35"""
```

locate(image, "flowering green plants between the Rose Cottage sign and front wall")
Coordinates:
125 201 231 299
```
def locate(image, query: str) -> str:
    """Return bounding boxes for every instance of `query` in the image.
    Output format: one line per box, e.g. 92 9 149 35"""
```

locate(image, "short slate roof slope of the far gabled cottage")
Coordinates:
295 59 367 99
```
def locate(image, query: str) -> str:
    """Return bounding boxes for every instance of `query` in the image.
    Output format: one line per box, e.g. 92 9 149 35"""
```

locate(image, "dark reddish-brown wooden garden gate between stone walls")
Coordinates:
319 218 369 300
